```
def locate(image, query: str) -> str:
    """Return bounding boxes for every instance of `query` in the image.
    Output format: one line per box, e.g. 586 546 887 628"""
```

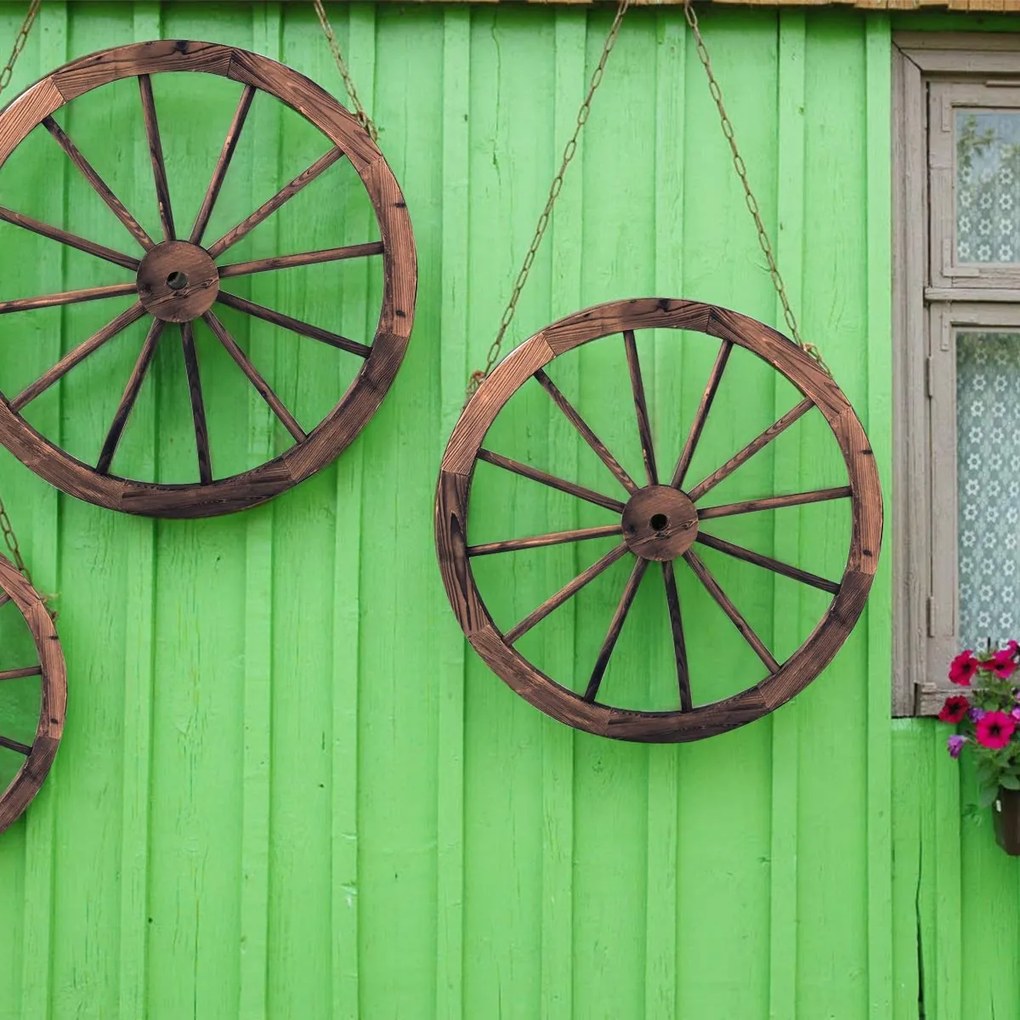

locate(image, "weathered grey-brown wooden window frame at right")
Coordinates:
893 33 1020 716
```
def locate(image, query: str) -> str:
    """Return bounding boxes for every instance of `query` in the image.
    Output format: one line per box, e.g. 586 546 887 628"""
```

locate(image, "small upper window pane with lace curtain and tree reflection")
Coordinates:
956 109 1020 262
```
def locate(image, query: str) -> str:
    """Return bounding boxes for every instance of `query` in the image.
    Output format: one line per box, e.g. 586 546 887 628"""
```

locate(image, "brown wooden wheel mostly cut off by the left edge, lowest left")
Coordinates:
0 556 67 832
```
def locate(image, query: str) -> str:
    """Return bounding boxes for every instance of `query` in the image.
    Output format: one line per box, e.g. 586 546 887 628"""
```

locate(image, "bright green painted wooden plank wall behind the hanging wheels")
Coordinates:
0 0 1020 1020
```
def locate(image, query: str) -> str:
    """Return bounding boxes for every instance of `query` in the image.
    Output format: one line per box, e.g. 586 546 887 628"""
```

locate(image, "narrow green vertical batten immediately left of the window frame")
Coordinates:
865 15 894 1016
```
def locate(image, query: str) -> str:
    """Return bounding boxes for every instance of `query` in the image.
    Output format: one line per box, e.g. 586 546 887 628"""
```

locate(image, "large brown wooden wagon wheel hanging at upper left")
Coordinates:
0 40 416 517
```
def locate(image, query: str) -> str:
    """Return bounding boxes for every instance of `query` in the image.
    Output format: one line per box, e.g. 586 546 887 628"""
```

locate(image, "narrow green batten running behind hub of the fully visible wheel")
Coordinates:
645 11 687 1020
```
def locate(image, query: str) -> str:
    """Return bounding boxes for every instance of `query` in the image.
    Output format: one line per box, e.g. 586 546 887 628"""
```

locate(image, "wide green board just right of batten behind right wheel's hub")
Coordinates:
677 7 775 1020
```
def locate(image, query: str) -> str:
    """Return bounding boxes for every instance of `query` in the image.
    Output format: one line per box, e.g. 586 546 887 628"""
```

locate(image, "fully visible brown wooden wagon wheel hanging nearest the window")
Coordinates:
436 298 882 742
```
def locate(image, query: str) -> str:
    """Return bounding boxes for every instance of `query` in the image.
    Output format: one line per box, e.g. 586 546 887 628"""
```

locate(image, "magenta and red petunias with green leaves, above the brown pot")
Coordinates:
938 641 1020 805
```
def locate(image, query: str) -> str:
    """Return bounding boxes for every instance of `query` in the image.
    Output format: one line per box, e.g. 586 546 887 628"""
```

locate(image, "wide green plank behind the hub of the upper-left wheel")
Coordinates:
144 4 249 1020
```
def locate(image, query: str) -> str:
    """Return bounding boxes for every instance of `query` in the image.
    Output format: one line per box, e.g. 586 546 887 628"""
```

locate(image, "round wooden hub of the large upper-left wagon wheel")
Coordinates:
138 241 219 322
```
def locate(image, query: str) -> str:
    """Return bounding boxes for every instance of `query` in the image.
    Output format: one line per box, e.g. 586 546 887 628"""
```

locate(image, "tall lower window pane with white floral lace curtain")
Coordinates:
954 333 1020 649
